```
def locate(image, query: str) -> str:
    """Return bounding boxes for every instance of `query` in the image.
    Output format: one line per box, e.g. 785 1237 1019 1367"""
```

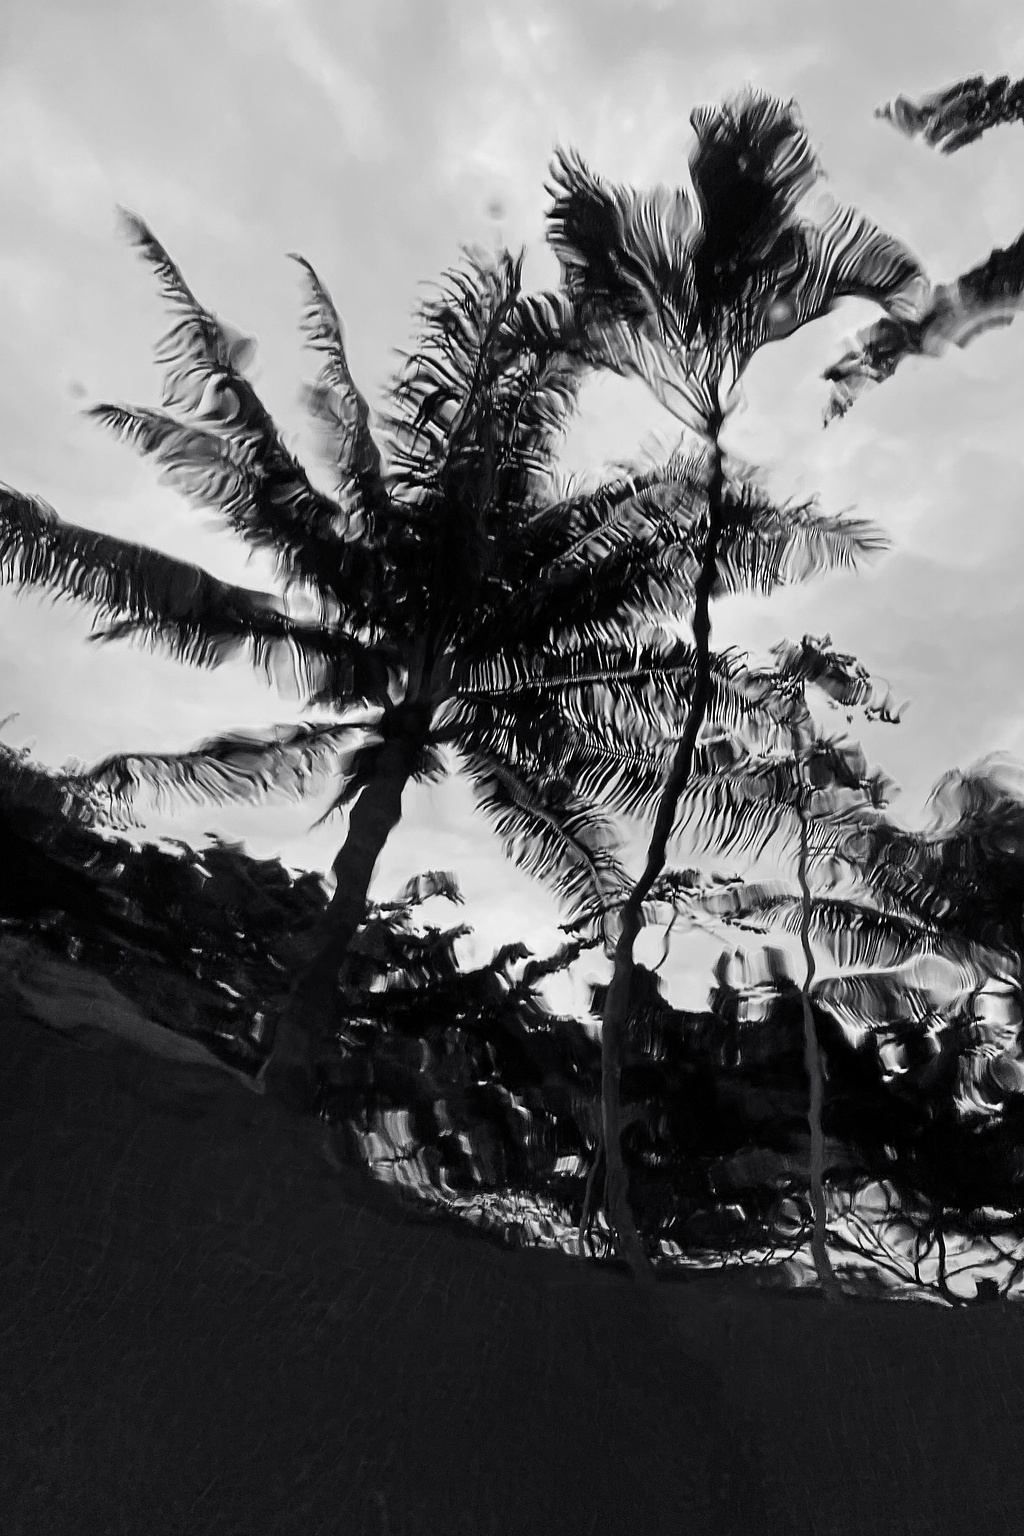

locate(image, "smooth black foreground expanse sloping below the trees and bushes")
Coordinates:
0 1008 1024 1536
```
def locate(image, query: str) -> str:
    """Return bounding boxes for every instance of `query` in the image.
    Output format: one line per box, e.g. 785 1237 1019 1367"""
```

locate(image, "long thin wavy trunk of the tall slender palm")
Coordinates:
600 413 723 1283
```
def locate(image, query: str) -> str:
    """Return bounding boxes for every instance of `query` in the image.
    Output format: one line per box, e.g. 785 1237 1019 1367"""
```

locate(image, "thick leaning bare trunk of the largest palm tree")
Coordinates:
261 739 411 1109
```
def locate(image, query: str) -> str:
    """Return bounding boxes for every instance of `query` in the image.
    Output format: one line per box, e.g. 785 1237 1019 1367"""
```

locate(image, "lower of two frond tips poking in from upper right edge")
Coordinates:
823 233 1024 425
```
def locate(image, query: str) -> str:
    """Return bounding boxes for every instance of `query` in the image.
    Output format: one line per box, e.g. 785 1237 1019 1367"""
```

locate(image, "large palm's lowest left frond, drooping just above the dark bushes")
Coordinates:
81 716 376 806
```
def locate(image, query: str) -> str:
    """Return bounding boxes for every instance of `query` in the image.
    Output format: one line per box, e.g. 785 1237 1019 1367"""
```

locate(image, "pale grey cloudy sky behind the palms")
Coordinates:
0 0 1024 1001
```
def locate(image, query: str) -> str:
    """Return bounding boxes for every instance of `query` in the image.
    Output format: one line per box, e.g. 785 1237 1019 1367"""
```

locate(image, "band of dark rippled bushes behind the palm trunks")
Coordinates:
0 734 1024 1304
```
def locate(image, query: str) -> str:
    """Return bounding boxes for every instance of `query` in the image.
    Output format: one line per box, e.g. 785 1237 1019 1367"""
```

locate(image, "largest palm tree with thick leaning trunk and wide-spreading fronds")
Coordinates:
0 215 761 1104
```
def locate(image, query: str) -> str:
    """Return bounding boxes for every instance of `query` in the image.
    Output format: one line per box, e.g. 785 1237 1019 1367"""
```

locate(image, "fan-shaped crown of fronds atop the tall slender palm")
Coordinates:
548 89 926 411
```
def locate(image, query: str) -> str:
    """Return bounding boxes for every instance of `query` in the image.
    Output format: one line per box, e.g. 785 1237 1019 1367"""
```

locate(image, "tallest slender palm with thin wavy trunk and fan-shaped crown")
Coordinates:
550 91 924 1278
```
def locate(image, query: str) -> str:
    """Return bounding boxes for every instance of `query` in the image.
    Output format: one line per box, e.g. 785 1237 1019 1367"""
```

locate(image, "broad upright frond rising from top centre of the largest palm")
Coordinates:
380 252 589 628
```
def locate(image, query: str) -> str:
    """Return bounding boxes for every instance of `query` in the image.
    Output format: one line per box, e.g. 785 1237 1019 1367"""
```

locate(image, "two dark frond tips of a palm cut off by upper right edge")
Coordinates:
824 75 1024 425
